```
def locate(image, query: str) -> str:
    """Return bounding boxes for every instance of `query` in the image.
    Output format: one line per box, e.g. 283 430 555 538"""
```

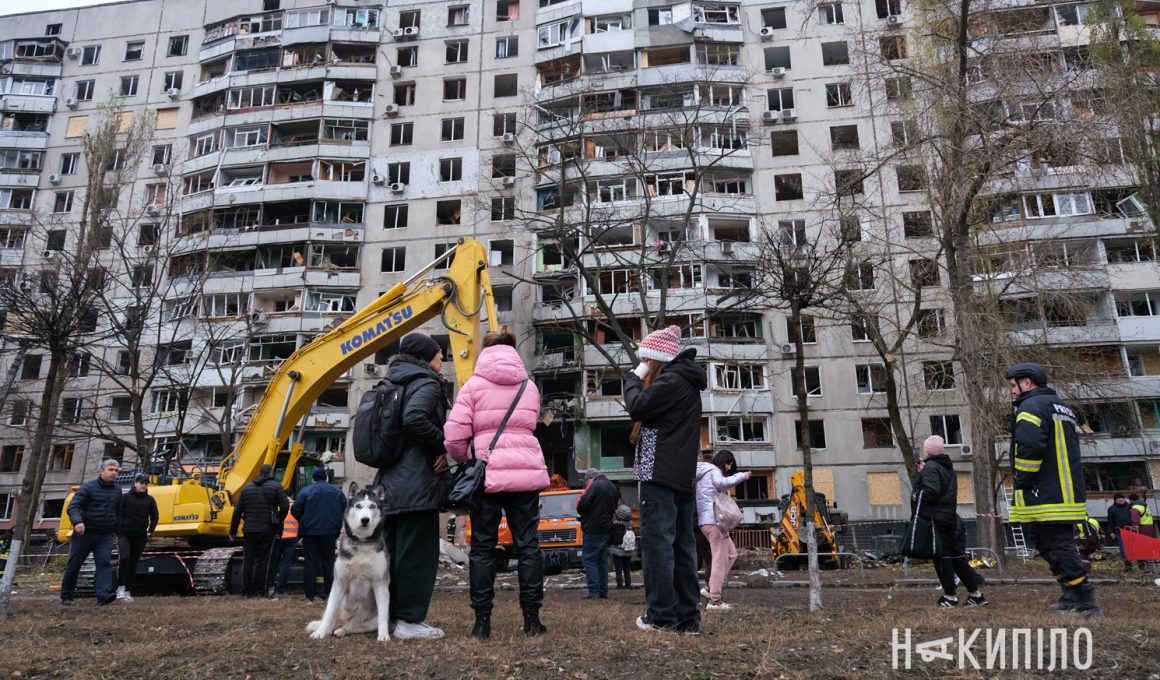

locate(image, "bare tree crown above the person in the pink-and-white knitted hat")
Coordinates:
505 64 757 370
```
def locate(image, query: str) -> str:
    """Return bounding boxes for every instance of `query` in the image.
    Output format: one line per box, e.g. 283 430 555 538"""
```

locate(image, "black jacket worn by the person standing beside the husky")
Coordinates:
375 354 448 515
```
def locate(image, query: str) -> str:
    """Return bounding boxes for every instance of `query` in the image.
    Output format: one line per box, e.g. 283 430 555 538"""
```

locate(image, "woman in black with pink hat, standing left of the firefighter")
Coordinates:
913 434 987 607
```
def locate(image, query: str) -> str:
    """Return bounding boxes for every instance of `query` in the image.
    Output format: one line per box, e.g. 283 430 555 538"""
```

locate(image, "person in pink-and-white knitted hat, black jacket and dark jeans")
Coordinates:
624 326 708 634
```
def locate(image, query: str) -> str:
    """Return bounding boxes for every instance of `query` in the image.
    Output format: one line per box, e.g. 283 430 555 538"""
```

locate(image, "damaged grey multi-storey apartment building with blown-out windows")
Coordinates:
0 0 1160 540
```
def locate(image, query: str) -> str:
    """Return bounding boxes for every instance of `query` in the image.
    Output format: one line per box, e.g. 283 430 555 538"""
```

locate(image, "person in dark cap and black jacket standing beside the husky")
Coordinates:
375 333 448 639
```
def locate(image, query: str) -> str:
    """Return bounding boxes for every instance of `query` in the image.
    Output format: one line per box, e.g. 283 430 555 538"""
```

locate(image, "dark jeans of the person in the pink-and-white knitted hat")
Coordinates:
639 482 701 630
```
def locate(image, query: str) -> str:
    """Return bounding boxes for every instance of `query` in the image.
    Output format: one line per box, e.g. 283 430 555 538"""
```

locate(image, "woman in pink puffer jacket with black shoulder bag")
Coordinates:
443 326 548 639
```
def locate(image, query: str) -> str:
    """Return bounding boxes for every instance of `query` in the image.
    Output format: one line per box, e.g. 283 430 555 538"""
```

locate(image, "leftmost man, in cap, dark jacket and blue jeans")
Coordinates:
60 458 121 605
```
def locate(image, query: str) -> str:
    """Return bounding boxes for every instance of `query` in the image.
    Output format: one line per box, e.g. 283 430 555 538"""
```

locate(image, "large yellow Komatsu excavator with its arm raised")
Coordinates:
57 238 496 593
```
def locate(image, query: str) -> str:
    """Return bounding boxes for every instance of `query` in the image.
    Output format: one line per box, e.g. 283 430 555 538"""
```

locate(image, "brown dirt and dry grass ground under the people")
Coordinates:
0 550 1160 680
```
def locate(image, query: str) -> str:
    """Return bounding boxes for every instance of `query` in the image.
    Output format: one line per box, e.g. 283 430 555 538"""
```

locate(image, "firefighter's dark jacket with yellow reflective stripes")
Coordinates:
1010 388 1087 523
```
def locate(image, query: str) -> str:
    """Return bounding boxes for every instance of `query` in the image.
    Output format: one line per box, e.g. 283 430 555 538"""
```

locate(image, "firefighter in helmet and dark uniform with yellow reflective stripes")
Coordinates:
1007 363 1102 616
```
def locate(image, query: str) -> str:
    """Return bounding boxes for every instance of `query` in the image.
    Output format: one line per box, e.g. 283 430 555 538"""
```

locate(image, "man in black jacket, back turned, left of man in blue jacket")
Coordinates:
230 464 290 598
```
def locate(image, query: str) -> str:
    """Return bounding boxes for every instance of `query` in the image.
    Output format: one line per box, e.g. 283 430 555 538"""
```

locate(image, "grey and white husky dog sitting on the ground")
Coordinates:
306 482 391 642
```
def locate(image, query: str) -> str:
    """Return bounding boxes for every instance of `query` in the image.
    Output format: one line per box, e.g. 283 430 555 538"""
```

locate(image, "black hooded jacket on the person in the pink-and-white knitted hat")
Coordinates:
624 348 708 493
